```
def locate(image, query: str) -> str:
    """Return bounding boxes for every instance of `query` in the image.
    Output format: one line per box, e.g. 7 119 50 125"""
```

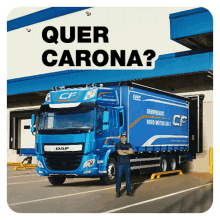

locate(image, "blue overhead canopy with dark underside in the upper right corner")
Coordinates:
170 8 213 49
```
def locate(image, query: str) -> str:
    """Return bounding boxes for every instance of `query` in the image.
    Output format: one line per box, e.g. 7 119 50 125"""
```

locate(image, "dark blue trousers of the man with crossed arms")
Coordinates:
116 163 131 193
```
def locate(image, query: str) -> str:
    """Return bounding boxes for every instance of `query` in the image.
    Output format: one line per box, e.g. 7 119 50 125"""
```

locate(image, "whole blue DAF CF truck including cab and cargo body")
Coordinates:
31 82 189 185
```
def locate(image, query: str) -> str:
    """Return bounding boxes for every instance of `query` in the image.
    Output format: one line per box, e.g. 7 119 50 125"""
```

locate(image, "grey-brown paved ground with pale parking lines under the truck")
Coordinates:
7 167 213 213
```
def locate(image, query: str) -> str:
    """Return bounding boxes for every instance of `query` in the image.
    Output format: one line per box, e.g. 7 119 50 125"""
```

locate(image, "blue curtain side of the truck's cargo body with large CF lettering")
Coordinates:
127 87 189 152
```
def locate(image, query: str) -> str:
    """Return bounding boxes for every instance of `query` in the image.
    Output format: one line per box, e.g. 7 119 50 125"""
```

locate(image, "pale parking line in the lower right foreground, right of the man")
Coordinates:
104 183 213 213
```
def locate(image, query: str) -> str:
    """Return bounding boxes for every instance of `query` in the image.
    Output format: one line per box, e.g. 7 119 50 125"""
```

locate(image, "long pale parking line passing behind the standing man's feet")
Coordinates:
9 178 163 205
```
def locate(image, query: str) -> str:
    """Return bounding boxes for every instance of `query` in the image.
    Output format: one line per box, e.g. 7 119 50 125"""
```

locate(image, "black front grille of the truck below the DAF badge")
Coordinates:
44 152 83 171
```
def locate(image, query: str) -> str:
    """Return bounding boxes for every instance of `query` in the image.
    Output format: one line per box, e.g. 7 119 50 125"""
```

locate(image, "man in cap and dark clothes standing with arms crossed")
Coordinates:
115 134 134 198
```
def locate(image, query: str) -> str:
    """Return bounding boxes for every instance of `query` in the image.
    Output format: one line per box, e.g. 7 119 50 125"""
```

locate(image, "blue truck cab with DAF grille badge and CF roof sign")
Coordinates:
32 86 126 184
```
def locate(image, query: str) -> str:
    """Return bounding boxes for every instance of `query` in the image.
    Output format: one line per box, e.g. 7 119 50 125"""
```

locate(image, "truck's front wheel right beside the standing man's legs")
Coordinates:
100 157 117 185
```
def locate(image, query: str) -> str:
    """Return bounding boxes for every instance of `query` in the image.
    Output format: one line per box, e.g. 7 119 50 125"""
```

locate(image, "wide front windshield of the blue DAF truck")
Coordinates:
39 110 94 133
